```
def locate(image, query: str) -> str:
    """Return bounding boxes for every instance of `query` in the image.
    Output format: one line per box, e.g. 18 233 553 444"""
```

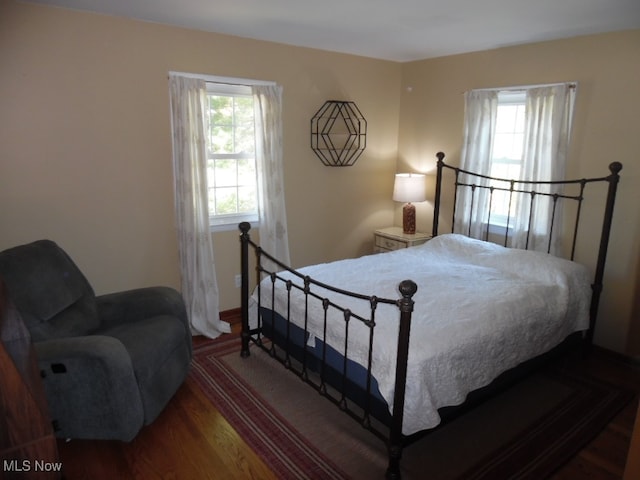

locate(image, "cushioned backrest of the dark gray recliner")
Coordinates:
0 240 99 342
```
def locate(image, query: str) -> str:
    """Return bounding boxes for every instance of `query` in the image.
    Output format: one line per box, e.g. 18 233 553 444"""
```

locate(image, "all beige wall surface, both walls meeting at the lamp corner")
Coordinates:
0 0 640 353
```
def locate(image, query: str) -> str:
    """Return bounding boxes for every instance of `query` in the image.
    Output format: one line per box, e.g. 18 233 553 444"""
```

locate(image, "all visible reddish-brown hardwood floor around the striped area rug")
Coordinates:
58 314 640 480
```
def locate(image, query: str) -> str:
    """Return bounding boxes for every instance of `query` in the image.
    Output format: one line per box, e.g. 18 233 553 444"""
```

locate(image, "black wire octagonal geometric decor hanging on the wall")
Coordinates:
311 100 367 167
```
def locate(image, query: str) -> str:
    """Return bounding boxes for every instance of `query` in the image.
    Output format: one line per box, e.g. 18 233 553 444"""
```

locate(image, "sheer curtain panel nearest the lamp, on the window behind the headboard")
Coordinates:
454 90 498 239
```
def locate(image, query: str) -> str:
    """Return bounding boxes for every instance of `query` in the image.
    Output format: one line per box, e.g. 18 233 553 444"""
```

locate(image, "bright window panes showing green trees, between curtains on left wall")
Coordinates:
205 82 260 230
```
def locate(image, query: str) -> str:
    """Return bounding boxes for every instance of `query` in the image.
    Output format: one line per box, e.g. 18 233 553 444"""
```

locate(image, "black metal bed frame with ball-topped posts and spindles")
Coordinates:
239 152 622 479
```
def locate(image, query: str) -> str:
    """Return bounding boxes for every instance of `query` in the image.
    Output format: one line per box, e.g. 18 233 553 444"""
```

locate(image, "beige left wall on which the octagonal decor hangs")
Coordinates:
0 0 401 310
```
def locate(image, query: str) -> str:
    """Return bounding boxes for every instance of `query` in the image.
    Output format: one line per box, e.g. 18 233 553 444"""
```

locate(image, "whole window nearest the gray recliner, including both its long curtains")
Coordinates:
169 72 290 328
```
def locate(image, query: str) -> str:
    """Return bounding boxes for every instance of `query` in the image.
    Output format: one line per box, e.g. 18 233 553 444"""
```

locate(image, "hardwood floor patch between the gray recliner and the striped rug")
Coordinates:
58 380 276 480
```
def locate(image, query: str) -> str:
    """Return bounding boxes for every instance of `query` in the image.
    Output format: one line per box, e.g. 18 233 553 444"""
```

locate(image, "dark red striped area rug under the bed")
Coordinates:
191 336 633 480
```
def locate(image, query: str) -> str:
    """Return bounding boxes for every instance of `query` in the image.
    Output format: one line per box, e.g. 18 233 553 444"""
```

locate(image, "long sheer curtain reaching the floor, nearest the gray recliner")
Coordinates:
169 74 231 338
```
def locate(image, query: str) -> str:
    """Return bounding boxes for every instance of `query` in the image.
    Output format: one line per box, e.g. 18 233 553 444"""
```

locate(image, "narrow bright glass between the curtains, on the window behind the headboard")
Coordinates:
490 91 526 227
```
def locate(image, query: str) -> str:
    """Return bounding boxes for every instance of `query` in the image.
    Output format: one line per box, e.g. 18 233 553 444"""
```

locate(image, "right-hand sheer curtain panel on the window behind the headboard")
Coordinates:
512 84 575 254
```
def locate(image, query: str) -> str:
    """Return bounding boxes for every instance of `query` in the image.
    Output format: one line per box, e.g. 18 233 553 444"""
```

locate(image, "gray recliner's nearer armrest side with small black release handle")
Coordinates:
34 335 144 441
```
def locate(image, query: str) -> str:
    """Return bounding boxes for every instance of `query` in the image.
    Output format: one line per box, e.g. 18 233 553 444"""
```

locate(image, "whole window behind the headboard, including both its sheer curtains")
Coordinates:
454 83 576 253
